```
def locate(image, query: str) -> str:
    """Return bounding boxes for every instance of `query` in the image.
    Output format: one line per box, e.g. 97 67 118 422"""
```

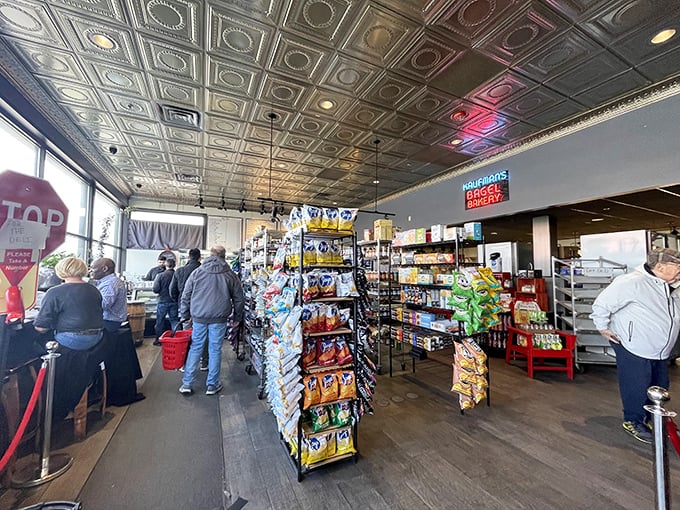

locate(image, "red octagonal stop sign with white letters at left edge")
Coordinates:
0 170 68 257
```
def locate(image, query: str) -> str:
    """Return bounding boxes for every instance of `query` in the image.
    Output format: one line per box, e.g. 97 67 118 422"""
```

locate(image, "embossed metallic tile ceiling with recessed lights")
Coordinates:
0 0 680 212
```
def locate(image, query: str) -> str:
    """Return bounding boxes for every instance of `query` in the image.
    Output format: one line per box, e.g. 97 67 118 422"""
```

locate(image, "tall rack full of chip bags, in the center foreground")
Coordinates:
264 206 375 481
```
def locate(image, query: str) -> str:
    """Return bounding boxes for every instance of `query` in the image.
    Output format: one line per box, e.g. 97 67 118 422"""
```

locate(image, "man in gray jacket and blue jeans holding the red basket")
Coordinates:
179 246 245 395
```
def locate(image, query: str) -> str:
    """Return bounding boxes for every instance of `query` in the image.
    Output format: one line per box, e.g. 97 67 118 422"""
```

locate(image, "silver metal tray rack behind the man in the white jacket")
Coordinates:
552 257 627 372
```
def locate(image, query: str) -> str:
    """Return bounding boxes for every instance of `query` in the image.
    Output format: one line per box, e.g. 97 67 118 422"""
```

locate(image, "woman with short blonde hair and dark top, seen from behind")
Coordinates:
33 257 104 351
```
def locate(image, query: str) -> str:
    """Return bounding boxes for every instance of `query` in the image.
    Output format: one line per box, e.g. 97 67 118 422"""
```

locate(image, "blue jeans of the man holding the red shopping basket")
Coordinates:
182 322 228 387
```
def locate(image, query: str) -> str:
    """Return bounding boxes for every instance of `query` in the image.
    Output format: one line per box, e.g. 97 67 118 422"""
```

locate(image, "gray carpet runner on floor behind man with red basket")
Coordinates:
79 361 224 510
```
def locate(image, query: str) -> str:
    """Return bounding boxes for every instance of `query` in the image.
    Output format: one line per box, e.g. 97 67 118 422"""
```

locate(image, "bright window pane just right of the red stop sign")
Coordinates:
44 154 89 236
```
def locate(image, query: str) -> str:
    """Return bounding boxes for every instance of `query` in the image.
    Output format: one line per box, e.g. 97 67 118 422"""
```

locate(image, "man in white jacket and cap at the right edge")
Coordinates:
590 248 680 443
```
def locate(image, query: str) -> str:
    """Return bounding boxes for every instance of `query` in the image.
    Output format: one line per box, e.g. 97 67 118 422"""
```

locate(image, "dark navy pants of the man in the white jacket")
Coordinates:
609 342 669 423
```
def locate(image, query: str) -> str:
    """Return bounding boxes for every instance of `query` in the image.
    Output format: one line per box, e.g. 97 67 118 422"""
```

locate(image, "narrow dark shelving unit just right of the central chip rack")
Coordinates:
357 239 399 377
